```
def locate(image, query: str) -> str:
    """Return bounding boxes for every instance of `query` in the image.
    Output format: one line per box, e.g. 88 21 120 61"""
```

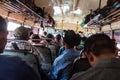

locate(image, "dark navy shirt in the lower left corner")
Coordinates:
0 55 40 80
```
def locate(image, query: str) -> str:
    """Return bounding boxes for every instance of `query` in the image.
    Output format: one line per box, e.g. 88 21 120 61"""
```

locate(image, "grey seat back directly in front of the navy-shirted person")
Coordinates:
1 50 40 71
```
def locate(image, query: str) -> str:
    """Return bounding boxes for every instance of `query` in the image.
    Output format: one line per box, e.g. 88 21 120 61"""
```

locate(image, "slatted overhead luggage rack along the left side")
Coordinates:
0 0 44 22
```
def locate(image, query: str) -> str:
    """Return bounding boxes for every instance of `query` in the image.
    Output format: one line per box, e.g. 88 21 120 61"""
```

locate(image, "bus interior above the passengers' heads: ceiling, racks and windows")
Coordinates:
0 0 120 79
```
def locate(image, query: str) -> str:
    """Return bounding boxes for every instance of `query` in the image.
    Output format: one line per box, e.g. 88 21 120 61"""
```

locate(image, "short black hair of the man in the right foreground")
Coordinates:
84 33 115 56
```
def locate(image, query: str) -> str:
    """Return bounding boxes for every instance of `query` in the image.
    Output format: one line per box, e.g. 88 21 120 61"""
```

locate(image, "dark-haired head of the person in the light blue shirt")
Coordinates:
62 30 76 48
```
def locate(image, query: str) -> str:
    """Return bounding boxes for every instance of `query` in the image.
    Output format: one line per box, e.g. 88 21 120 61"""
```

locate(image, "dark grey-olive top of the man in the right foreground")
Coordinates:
70 58 120 80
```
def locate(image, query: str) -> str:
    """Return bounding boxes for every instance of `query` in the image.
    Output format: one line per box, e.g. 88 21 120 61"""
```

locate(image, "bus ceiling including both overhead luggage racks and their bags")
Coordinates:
0 0 120 31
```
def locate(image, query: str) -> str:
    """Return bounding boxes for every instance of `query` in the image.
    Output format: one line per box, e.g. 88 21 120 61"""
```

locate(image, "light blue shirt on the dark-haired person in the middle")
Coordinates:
49 49 79 80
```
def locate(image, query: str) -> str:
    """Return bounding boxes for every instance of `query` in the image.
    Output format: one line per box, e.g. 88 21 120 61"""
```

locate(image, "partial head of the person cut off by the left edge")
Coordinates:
0 16 8 53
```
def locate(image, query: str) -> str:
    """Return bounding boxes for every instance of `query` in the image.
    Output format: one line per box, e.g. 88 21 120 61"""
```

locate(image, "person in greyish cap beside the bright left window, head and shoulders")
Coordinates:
6 26 31 50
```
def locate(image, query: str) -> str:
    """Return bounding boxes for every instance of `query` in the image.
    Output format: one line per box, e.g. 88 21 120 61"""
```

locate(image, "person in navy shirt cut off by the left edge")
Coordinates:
0 17 40 80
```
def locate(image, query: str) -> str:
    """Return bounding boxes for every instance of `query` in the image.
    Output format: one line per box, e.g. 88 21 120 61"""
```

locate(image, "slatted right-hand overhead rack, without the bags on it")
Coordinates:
87 8 120 28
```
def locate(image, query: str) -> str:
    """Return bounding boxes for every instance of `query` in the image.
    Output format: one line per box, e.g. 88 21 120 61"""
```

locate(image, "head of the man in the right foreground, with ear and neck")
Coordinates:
84 33 117 65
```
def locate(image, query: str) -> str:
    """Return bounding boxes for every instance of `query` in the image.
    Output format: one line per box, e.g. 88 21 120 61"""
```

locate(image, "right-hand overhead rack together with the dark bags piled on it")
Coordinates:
85 0 120 28
